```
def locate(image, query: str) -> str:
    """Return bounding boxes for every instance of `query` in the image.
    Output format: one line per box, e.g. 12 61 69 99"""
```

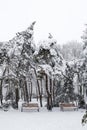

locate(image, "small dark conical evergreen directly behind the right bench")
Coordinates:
60 63 75 102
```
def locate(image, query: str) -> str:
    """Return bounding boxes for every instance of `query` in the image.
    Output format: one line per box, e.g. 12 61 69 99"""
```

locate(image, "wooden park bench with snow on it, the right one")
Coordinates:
59 103 78 111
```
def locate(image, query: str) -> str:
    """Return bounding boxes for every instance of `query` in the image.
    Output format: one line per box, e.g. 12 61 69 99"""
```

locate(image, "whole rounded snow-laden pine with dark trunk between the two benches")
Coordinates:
34 34 64 109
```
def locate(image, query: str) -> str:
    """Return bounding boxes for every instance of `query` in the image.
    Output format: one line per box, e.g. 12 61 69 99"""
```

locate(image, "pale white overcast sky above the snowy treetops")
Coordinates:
0 0 87 44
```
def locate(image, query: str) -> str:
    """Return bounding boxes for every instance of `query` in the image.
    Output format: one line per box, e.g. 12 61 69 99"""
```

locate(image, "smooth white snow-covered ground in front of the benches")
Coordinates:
0 108 87 130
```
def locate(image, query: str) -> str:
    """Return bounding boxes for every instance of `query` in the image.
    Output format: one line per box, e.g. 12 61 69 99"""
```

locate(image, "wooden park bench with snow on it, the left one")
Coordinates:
21 103 39 112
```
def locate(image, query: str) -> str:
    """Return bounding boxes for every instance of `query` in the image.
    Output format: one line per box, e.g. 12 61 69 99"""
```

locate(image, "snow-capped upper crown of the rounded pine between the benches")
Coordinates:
35 33 63 69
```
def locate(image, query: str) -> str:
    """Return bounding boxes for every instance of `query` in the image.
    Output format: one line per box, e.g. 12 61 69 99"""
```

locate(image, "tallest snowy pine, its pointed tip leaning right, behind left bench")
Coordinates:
14 22 35 102
